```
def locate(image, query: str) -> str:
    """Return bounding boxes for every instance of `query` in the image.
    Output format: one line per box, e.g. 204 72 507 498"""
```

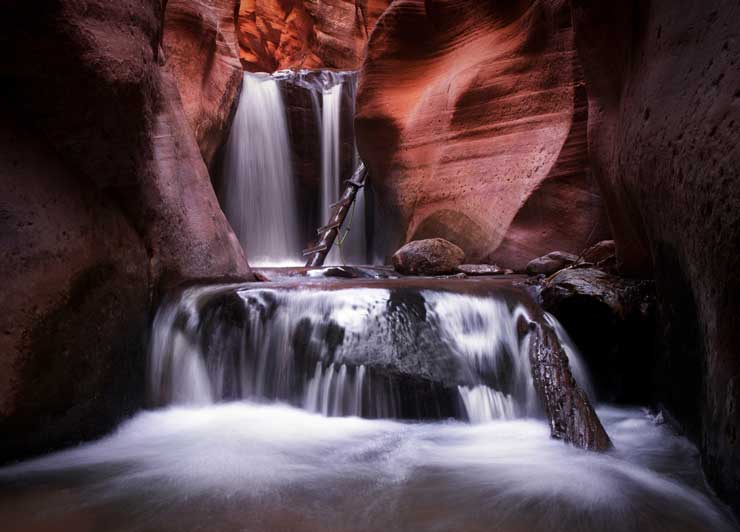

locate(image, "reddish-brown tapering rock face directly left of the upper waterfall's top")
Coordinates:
163 0 243 166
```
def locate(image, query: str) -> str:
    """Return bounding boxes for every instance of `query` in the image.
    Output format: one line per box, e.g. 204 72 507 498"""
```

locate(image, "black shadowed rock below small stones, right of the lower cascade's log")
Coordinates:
540 268 655 403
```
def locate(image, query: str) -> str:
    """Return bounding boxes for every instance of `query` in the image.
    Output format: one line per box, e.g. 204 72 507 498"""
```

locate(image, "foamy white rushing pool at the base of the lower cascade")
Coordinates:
0 402 735 532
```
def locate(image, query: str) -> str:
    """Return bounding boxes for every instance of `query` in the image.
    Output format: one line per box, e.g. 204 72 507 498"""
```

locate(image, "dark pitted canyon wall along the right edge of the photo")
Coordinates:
572 0 740 511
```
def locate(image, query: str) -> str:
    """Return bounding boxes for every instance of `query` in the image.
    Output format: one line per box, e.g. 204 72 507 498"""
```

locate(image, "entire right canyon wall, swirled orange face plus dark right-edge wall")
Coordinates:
356 0 740 511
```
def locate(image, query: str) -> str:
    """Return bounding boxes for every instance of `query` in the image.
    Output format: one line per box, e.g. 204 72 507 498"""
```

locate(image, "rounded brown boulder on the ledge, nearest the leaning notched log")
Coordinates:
392 238 465 275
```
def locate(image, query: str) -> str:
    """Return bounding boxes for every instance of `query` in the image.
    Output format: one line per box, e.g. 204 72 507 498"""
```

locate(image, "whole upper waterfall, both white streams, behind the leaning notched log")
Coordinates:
219 70 370 266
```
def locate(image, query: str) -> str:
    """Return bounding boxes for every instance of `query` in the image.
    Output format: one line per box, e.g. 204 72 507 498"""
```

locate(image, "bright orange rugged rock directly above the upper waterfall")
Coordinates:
238 0 391 72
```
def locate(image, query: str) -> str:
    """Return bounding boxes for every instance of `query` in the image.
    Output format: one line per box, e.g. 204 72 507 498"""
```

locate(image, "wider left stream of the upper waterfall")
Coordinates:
221 73 304 265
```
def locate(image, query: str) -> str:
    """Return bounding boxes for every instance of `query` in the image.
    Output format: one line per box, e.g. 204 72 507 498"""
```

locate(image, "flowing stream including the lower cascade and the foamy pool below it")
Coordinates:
0 280 736 532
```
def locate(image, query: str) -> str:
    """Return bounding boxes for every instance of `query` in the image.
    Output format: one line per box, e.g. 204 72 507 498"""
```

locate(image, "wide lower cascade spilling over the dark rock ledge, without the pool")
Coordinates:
150 283 588 423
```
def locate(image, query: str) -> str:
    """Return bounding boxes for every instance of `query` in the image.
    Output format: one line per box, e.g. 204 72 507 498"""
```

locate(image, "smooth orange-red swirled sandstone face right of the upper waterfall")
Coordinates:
356 0 607 270
